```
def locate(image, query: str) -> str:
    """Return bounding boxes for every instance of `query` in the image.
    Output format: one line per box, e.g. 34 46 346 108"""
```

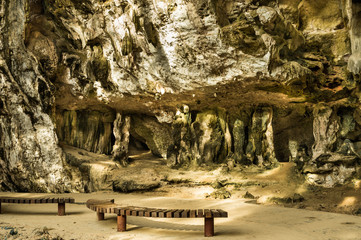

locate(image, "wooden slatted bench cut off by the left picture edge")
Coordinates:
0 197 74 216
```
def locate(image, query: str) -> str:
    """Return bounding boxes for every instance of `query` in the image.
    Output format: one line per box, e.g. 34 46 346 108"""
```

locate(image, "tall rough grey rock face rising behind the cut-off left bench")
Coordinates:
0 1 71 192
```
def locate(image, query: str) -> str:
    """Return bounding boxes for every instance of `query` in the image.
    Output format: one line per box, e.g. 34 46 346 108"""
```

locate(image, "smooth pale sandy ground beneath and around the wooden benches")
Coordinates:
0 192 361 240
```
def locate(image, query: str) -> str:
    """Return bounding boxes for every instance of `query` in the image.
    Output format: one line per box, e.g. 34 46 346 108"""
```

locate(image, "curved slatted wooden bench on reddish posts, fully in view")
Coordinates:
86 199 228 237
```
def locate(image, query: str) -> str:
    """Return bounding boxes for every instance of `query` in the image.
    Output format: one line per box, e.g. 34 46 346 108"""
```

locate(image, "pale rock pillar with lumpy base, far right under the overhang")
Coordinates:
303 107 360 187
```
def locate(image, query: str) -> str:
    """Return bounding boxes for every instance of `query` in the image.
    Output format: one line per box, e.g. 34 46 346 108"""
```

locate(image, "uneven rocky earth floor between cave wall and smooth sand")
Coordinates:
63 146 361 216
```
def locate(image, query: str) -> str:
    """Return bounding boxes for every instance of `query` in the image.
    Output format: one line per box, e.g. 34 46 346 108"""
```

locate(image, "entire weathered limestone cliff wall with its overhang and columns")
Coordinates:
0 0 361 192
